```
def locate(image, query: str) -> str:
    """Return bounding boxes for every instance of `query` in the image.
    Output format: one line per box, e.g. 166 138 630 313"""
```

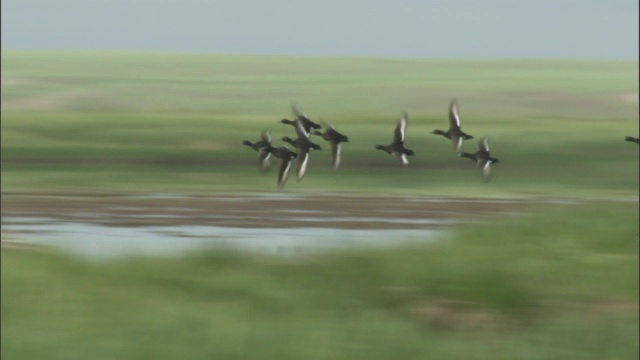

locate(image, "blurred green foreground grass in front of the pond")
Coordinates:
1 203 639 360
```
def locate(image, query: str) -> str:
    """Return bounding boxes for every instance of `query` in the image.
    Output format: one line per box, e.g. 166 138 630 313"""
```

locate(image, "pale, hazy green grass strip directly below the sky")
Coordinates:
2 51 638 118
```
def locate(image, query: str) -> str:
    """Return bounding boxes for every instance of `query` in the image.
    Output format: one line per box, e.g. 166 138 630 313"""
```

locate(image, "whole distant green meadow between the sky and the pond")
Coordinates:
2 51 638 197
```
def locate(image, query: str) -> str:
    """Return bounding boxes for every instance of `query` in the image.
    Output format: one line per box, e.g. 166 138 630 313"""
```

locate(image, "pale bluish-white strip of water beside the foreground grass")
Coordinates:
2 217 443 258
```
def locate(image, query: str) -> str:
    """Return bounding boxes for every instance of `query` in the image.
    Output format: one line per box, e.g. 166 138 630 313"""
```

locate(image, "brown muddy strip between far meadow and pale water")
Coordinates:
2 193 527 229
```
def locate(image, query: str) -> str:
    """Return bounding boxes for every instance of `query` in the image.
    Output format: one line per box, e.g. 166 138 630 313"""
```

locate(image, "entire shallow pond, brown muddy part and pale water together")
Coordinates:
2 194 540 258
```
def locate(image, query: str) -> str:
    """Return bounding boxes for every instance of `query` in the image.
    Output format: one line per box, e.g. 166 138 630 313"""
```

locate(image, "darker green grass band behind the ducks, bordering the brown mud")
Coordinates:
2 111 638 198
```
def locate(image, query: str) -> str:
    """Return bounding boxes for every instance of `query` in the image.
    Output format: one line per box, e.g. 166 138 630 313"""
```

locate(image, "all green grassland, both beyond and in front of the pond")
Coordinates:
1 51 640 360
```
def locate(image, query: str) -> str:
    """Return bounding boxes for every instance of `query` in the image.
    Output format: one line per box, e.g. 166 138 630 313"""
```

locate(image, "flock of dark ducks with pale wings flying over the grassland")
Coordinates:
242 98 640 188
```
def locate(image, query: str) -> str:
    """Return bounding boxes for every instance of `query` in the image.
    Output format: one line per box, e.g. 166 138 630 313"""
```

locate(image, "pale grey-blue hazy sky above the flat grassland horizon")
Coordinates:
2 0 638 60
